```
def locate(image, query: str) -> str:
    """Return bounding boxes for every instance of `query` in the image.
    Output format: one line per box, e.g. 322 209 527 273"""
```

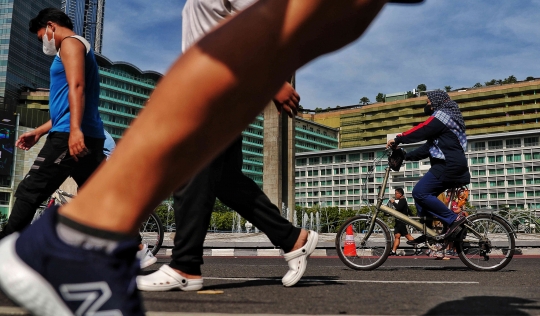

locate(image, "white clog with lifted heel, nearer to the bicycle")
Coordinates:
281 230 319 286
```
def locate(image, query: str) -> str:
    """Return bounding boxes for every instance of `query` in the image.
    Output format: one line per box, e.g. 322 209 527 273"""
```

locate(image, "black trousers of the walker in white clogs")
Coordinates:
170 138 300 275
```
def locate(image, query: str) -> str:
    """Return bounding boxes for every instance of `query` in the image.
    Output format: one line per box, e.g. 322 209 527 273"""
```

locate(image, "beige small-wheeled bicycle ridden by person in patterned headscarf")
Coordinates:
335 148 516 271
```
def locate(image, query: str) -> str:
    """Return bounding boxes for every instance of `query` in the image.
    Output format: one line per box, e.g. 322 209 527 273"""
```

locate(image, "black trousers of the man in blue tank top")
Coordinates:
0 132 105 239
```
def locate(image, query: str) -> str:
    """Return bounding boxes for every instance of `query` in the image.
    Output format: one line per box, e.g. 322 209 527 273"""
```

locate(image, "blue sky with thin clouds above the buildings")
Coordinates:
102 0 540 109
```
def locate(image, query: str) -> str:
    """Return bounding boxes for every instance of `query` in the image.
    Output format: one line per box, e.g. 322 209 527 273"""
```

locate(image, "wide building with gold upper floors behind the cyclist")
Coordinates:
296 80 540 210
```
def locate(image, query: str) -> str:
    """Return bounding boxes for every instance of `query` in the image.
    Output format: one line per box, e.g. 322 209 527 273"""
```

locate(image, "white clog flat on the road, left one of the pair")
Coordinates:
137 265 203 292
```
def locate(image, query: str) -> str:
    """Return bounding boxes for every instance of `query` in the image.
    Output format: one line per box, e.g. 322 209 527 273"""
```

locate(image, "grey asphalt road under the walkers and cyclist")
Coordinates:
0 256 540 315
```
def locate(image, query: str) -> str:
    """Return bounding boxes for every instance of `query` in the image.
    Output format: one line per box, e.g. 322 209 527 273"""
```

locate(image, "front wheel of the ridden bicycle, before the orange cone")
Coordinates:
336 215 392 270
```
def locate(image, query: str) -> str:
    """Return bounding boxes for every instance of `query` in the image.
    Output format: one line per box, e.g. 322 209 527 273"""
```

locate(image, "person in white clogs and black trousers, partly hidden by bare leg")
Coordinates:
137 0 318 291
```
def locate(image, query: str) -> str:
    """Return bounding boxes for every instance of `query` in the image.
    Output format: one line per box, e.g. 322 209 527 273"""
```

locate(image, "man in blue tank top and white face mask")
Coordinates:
0 8 105 238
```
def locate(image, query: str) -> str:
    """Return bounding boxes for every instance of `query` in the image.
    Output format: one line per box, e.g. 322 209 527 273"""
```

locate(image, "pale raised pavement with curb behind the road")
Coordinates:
163 233 540 256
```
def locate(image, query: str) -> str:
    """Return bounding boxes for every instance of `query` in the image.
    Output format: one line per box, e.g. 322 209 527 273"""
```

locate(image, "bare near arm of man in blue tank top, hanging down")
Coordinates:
60 38 87 161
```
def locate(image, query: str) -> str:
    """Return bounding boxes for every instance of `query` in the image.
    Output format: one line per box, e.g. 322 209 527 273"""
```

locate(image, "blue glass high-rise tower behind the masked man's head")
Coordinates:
61 0 105 53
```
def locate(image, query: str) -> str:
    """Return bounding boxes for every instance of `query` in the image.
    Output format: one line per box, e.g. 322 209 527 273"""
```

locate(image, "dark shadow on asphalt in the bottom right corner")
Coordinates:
424 296 540 316
